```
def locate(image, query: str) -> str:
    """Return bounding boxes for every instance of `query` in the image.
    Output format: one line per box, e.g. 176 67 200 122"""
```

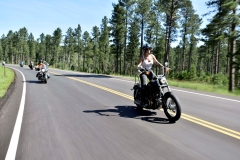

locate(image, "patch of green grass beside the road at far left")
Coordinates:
0 66 14 98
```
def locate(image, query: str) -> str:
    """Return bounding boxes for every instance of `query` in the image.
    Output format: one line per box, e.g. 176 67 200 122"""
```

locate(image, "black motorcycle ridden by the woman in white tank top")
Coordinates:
133 63 181 122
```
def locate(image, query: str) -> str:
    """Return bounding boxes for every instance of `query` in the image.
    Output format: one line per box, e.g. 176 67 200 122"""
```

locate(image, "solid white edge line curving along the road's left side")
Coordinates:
5 67 26 160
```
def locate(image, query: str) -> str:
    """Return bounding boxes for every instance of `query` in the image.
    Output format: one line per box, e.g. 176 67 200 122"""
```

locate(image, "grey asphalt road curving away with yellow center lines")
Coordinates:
0 65 240 160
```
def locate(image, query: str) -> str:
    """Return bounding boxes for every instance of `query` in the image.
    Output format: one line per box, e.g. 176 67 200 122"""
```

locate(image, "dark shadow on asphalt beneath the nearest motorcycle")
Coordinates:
83 106 171 124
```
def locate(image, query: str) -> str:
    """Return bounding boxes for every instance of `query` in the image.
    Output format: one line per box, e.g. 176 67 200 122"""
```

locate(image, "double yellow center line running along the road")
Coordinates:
50 72 240 140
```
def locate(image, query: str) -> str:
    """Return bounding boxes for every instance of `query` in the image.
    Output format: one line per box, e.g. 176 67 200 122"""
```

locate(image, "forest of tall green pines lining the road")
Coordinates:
0 0 240 92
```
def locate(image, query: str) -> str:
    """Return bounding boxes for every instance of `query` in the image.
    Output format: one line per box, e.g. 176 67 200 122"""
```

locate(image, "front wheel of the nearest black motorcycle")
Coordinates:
163 92 181 122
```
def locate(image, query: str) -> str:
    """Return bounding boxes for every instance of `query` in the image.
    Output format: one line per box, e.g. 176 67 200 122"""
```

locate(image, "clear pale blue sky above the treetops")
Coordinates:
0 0 208 39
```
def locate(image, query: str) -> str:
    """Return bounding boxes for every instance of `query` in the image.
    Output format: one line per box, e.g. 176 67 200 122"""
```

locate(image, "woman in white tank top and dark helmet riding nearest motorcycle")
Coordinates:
137 43 163 107
